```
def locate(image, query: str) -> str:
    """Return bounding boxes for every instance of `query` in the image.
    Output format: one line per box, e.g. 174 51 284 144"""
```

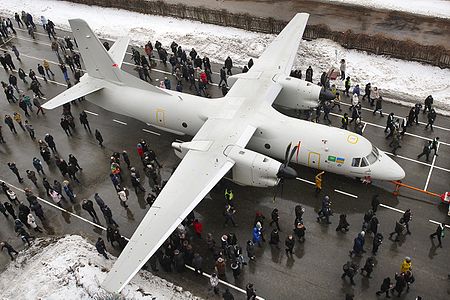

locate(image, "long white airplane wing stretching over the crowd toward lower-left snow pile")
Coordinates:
102 119 256 293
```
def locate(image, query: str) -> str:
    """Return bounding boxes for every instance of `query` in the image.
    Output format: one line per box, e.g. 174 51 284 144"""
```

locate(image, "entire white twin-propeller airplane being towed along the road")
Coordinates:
43 13 405 292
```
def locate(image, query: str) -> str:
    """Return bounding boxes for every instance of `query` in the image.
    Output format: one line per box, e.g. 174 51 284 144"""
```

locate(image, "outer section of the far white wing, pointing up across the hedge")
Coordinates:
249 13 309 75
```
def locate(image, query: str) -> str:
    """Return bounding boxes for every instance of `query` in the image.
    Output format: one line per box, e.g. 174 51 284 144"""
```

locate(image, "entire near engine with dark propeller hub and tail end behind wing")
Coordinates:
172 141 297 187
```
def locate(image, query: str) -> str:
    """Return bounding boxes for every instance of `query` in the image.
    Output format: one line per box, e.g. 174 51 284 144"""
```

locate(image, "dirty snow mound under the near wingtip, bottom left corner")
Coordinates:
0 235 200 300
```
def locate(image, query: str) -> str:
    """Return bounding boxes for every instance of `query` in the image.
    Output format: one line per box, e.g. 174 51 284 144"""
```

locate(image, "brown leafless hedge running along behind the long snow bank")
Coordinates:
69 0 450 68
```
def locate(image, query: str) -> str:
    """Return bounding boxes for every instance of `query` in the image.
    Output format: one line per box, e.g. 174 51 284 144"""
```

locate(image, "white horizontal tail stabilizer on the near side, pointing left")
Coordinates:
42 74 105 109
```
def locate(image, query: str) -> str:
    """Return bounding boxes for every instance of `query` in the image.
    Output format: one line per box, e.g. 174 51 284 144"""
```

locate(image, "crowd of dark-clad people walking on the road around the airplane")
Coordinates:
0 12 444 300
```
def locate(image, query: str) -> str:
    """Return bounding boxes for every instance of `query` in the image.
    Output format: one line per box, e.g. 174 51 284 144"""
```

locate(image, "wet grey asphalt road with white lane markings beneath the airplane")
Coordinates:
0 22 450 299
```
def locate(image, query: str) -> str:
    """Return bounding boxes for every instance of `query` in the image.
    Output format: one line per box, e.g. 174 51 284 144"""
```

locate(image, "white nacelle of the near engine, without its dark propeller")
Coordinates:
225 146 281 187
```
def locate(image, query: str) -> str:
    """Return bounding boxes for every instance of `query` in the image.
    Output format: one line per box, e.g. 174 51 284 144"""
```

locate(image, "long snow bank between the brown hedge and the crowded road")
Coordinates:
0 0 450 114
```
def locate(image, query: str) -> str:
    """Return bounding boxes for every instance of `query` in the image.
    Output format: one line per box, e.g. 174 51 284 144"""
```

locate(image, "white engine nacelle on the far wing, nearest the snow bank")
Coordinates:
274 75 321 110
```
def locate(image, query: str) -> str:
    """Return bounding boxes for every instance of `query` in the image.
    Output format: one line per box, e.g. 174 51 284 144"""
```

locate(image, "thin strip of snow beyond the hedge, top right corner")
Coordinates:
321 0 450 18
